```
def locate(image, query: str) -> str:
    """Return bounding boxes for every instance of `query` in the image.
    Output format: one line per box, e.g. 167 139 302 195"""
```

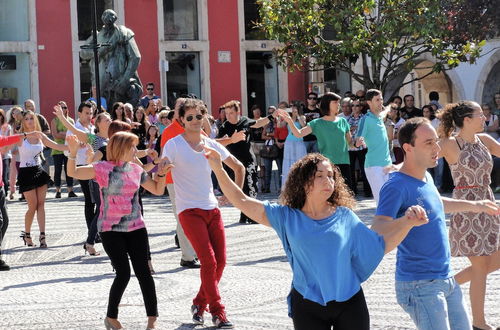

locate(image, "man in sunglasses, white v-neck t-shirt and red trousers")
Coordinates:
163 99 245 329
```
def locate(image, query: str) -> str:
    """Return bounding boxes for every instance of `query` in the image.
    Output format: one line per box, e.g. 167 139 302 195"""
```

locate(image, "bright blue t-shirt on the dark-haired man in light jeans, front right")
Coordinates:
376 172 450 281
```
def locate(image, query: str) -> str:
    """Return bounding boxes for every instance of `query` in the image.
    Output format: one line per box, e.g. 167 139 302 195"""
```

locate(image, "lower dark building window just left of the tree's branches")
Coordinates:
246 52 279 112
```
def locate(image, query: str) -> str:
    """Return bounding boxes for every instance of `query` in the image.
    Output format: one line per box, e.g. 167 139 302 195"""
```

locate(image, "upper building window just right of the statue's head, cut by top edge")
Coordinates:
163 0 199 40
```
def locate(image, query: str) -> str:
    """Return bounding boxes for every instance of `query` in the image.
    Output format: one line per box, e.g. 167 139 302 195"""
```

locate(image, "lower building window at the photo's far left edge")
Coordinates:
0 53 31 106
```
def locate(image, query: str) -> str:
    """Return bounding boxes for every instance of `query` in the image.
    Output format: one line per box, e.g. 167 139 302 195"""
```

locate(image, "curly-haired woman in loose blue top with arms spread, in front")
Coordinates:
201 147 427 330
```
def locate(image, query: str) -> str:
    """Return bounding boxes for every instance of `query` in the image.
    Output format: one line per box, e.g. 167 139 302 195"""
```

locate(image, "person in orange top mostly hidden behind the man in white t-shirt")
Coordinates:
159 98 200 268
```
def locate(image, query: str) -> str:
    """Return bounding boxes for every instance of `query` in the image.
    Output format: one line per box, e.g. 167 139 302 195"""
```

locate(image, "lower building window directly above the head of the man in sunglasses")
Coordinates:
165 52 202 109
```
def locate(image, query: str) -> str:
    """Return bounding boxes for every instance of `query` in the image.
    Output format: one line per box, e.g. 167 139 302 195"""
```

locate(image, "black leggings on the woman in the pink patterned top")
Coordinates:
100 228 158 319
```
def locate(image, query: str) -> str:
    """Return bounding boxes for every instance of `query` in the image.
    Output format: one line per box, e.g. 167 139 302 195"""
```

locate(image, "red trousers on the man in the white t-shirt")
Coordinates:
179 208 226 315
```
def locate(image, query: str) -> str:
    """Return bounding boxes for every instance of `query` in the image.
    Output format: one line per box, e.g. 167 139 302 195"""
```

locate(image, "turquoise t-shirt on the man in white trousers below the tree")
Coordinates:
358 111 392 168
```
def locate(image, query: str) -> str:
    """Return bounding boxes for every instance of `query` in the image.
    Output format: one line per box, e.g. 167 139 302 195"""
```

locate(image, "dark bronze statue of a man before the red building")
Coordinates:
80 9 142 107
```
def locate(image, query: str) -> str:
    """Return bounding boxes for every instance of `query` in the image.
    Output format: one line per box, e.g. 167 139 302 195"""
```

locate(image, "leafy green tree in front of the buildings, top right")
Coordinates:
257 0 500 95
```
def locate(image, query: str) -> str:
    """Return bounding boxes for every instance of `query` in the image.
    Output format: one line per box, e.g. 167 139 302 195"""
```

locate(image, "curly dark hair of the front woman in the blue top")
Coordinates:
279 153 356 210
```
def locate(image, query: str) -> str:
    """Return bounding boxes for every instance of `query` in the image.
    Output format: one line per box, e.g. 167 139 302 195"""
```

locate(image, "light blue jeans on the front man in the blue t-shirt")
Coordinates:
396 277 472 330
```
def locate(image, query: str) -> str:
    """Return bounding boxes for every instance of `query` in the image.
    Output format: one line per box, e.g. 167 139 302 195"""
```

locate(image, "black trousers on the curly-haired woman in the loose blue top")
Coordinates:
290 289 370 330
